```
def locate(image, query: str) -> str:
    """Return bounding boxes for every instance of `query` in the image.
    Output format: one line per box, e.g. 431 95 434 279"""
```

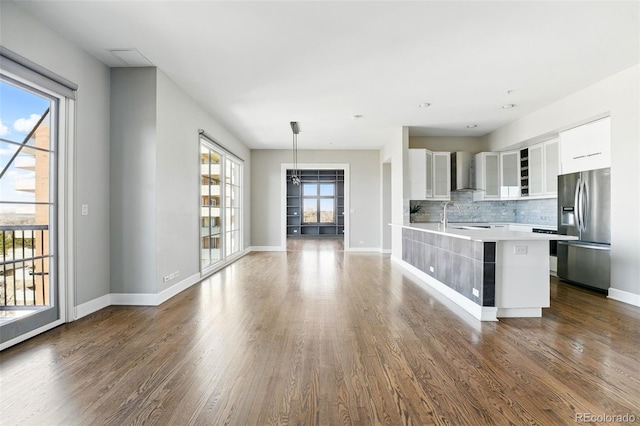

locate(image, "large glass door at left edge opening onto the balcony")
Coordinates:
0 65 71 347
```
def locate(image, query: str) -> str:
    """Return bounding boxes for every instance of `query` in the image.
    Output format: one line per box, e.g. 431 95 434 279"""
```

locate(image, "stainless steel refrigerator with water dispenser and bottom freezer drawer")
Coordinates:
558 168 611 291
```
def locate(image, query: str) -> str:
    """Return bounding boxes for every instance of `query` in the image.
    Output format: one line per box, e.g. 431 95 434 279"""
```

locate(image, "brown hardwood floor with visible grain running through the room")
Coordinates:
0 239 640 425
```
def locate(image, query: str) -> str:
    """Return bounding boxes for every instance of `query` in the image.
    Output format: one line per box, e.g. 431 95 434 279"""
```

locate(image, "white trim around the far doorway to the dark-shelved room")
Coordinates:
280 163 351 250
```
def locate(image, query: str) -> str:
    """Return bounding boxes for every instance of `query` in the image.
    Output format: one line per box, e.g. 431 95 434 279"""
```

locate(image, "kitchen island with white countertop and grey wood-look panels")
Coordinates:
391 223 575 321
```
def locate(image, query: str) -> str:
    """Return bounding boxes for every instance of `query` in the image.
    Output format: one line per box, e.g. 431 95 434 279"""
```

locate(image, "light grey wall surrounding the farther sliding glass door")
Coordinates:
156 71 251 291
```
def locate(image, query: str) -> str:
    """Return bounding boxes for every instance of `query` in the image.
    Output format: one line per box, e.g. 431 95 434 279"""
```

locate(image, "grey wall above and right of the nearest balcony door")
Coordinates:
0 1 110 306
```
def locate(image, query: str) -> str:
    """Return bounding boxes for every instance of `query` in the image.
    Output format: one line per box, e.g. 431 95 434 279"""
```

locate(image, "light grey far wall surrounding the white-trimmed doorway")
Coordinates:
251 150 381 249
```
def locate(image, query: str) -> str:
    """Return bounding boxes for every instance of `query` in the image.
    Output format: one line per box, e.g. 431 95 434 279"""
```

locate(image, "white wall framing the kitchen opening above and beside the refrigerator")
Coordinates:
486 65 640 304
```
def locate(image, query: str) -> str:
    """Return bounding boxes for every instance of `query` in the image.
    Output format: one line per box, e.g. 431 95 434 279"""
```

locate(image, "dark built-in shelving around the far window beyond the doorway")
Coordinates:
287 170 344 237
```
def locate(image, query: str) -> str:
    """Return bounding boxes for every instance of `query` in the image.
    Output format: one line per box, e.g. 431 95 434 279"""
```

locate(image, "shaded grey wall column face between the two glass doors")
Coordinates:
110 67 157 294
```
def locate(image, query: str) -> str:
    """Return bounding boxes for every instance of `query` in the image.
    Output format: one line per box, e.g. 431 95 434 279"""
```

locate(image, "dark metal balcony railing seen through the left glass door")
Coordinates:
0 225 51 309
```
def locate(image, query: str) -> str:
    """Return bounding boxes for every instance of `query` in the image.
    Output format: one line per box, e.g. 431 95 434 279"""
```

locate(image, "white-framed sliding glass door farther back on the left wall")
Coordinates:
200 136 243 273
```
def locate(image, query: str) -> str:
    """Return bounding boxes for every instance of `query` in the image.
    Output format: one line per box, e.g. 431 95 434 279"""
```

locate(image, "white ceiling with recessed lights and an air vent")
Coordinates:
11 0 640 149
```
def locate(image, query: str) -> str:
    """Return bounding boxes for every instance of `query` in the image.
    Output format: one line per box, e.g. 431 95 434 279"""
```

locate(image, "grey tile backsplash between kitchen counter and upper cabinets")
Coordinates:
410 191 557 226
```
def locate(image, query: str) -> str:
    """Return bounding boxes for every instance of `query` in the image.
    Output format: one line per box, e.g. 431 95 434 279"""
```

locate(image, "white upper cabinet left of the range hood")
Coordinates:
409 149 451 200
